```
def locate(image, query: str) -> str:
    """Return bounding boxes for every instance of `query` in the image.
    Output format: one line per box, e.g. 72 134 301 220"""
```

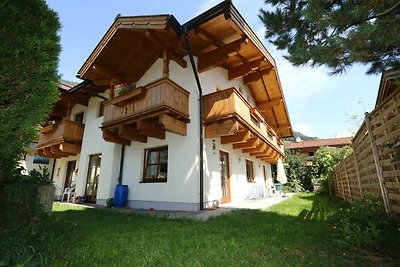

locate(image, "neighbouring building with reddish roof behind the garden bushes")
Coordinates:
285 137 351 157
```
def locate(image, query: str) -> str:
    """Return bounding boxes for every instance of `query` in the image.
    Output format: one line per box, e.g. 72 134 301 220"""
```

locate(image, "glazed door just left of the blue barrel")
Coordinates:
85 154 101 202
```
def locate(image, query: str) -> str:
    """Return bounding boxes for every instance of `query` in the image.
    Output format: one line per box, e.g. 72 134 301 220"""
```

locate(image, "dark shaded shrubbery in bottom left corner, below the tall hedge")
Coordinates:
0 173 50 266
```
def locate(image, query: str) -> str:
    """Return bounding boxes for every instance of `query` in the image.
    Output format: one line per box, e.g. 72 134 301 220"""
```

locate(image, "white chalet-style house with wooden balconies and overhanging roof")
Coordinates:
37 1 292 211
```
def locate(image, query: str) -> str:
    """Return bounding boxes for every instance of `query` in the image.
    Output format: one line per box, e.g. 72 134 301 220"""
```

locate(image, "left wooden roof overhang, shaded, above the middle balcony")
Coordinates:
78 15 187 88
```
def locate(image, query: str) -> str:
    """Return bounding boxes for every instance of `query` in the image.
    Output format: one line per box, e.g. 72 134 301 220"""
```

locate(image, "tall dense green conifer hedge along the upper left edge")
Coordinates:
0 0 60 183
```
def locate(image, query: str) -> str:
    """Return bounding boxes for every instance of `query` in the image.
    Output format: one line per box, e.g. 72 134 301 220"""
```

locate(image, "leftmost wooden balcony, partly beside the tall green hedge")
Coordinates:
37 119 85 158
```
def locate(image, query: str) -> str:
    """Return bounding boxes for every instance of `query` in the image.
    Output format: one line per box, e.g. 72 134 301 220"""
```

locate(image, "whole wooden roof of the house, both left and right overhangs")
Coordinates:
74 0 293 137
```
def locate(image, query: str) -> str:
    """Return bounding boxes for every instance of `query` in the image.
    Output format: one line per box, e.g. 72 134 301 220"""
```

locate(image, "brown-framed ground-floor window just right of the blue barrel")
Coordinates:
142 146 168 182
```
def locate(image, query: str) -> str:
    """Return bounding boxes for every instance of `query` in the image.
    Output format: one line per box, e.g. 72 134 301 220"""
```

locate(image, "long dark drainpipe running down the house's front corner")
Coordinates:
183 24 204 210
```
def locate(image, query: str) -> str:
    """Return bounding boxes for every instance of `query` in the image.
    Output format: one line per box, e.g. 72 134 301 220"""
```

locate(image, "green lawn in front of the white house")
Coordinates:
39 194 396 266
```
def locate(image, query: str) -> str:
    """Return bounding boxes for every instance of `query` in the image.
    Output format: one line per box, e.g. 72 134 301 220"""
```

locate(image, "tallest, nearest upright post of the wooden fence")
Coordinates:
365 112 392 213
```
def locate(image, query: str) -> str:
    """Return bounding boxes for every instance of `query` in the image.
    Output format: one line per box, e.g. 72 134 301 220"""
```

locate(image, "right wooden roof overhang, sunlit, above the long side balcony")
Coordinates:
182 1 293 137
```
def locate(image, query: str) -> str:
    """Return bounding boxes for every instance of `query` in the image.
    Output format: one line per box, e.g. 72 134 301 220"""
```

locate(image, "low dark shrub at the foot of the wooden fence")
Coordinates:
332 195 400 251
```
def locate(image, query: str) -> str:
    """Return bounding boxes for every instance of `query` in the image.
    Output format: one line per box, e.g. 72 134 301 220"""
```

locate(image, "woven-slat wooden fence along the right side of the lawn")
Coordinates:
331 88 400 215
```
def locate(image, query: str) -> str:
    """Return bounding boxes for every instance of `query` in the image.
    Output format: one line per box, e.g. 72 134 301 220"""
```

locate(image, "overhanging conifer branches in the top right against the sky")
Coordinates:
259 0 400 74
